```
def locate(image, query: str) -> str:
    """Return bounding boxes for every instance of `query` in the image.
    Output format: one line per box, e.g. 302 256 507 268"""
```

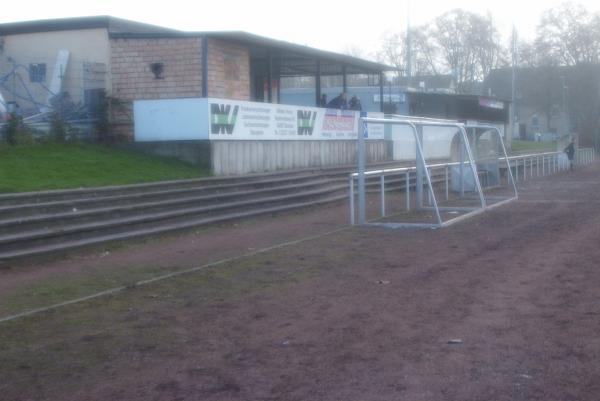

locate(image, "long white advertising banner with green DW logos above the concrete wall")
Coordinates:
134 98 384 141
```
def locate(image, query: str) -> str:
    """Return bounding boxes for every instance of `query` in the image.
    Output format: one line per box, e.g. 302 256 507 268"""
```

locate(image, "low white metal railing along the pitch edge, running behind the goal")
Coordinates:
348 148 596 225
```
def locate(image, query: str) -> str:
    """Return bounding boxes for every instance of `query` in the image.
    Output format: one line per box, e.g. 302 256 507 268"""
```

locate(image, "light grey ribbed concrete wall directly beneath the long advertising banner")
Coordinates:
211 140 391 175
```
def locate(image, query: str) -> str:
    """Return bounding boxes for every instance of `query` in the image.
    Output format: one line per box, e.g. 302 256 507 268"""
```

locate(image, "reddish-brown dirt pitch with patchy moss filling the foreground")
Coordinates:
0 164 600 401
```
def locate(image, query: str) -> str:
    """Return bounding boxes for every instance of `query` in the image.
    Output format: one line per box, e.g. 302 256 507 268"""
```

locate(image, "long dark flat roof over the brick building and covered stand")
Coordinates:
0 16 393 76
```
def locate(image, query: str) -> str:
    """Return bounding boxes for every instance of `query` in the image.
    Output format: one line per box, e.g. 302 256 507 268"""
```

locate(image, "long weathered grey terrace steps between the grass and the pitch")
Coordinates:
0 165 360 261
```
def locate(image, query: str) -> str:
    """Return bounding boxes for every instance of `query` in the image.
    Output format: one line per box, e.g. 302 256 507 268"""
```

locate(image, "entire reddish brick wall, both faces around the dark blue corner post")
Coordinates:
110 37 250 138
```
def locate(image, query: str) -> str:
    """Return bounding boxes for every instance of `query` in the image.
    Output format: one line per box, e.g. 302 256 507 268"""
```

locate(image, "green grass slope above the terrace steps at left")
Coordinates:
0 143 209 192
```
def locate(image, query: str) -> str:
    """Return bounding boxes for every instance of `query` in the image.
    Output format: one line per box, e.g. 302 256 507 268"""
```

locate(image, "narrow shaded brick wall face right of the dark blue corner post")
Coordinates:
208 39 250 100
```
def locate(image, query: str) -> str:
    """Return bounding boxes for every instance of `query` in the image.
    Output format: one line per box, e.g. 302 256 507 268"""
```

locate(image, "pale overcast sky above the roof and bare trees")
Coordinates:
0 0 600 59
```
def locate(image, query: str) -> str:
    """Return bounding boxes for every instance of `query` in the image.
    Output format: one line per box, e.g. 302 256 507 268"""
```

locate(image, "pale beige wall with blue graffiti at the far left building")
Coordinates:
0 28 110 109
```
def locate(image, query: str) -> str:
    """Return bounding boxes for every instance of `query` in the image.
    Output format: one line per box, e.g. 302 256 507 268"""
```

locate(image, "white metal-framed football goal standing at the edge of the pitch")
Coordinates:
350 116 517 228
